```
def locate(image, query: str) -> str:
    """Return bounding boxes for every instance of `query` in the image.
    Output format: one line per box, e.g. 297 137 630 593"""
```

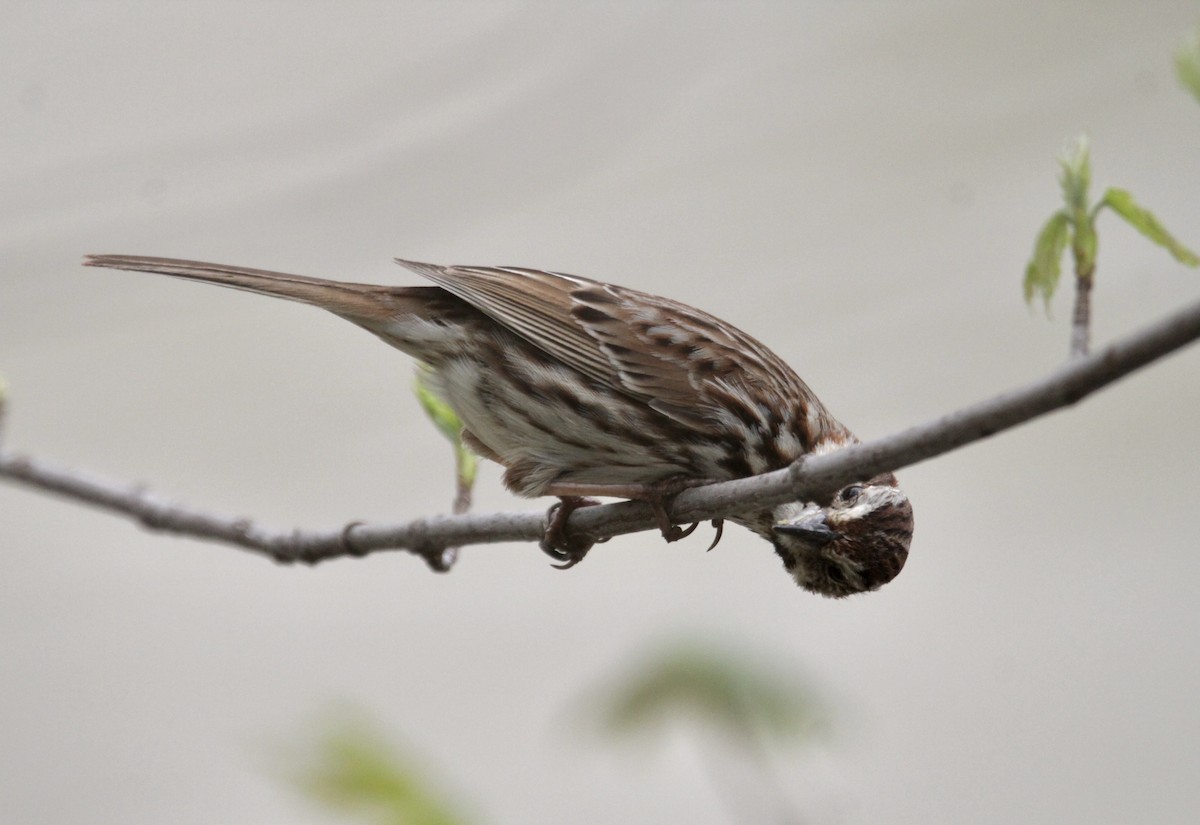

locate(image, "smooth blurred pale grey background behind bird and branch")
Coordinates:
0 2 1200 824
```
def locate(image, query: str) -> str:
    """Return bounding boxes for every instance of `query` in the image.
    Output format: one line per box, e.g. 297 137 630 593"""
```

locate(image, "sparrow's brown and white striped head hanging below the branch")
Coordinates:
760 474 912 598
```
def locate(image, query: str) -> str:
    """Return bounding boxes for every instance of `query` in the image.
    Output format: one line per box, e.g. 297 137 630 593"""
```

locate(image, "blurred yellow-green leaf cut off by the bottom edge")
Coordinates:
283 721 464 825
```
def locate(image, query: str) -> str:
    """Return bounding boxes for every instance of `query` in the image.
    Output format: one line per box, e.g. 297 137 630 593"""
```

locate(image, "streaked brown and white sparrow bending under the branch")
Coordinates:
85 255 912 596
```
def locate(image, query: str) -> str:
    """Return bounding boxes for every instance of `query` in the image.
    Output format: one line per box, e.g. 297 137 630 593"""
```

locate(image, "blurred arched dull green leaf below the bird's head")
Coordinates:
601 646 826 741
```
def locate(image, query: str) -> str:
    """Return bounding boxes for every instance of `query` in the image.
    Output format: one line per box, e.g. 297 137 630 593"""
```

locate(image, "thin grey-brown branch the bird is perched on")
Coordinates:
0 296 1200 564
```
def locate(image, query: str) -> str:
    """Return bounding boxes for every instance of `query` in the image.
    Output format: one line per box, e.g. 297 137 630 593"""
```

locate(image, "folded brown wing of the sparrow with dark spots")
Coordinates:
397 259 815 432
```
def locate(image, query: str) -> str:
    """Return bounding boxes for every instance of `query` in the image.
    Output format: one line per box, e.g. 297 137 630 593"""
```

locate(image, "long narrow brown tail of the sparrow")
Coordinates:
84 255 408 326
